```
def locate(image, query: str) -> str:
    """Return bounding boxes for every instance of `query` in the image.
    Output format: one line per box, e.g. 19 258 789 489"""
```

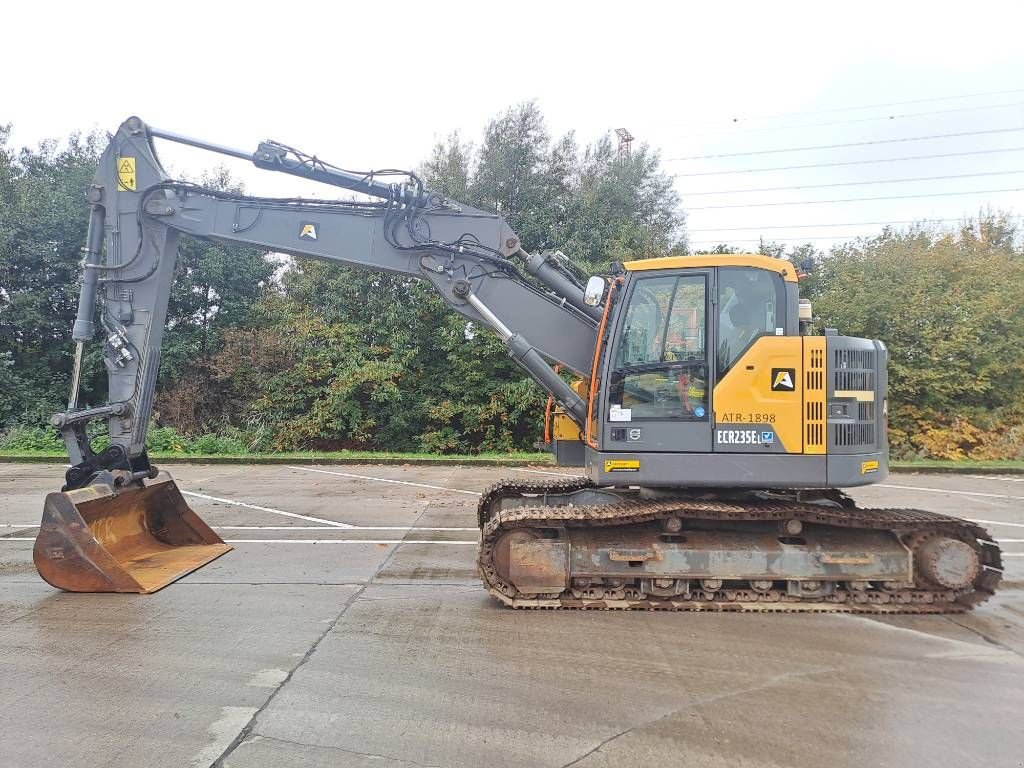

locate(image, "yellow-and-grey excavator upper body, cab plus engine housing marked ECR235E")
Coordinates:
573 254 888 487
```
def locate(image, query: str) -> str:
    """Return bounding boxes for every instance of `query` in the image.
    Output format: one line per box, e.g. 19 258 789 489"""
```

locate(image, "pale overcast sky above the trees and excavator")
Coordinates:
0 0 1024 248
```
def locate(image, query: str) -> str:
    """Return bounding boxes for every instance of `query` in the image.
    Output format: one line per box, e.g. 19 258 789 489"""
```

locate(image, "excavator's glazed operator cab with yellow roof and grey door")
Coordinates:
602 256 797 460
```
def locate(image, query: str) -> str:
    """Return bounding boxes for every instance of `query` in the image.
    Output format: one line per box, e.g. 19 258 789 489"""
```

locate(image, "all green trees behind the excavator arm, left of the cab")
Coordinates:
0 102 683 452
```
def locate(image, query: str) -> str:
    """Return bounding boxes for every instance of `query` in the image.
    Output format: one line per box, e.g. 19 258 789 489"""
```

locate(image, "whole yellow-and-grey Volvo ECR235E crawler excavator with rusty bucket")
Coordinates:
34 117 1001 613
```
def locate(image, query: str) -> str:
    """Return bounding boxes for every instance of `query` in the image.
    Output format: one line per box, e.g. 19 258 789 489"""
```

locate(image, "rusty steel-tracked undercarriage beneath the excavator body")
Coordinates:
478 477 1002 613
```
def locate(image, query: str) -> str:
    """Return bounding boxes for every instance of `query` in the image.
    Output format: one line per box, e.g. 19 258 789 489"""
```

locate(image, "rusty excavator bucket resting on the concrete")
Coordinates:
33 472 231 594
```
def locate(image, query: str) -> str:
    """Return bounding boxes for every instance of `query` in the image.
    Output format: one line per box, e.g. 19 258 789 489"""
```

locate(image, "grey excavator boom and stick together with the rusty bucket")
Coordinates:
33 118 604 593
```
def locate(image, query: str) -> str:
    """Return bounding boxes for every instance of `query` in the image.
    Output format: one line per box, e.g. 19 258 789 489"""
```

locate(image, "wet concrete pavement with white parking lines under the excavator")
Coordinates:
0 464 1024 768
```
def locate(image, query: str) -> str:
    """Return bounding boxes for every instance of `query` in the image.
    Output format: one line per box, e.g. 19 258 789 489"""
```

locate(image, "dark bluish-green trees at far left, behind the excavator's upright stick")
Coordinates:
0 126 274 436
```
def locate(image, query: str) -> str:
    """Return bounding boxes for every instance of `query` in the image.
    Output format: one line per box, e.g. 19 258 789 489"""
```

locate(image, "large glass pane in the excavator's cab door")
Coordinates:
609 274 708 421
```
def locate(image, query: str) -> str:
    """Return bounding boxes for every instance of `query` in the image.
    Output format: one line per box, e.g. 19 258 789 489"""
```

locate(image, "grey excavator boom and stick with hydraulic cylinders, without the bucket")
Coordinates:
54 118 603 488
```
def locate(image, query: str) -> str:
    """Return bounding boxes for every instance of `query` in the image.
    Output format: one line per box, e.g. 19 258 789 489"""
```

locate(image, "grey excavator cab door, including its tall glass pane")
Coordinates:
600 269 714 453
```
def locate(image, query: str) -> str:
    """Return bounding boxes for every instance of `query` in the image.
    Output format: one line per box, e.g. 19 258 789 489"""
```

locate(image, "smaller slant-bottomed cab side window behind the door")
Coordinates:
717 267 785 380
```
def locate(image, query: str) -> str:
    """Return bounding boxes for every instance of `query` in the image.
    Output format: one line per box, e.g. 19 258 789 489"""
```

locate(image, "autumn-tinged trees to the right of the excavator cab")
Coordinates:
812 217 1024 458
